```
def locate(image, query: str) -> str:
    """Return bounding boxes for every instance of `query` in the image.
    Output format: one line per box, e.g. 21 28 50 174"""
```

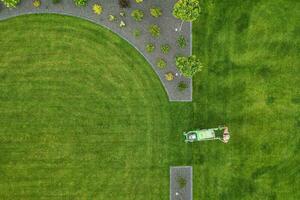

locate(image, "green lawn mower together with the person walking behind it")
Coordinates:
183 126 230 143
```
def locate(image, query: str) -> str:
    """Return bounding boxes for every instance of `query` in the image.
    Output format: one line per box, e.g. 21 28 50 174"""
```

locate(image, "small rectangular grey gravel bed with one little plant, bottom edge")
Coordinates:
170 166 193 200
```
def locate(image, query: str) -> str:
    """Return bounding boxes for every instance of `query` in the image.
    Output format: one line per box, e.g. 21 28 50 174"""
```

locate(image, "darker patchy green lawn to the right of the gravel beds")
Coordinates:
193 0 300 199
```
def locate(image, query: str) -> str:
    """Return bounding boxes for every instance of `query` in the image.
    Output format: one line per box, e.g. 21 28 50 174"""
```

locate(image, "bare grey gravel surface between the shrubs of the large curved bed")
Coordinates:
0 0 192 101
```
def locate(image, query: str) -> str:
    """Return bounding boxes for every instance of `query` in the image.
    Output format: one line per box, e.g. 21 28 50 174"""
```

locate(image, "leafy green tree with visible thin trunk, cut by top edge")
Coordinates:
173 0 201 31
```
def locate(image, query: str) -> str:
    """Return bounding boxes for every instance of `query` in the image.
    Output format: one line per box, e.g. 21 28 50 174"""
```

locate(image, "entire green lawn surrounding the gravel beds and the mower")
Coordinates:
0 0 300 200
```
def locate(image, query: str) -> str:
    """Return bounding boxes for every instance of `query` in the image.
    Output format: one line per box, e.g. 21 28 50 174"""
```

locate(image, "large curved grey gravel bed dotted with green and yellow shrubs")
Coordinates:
0 0 192 101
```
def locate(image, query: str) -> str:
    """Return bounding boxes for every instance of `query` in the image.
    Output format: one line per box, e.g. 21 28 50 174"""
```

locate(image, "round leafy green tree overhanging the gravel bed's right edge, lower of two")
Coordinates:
176 55 203 77
